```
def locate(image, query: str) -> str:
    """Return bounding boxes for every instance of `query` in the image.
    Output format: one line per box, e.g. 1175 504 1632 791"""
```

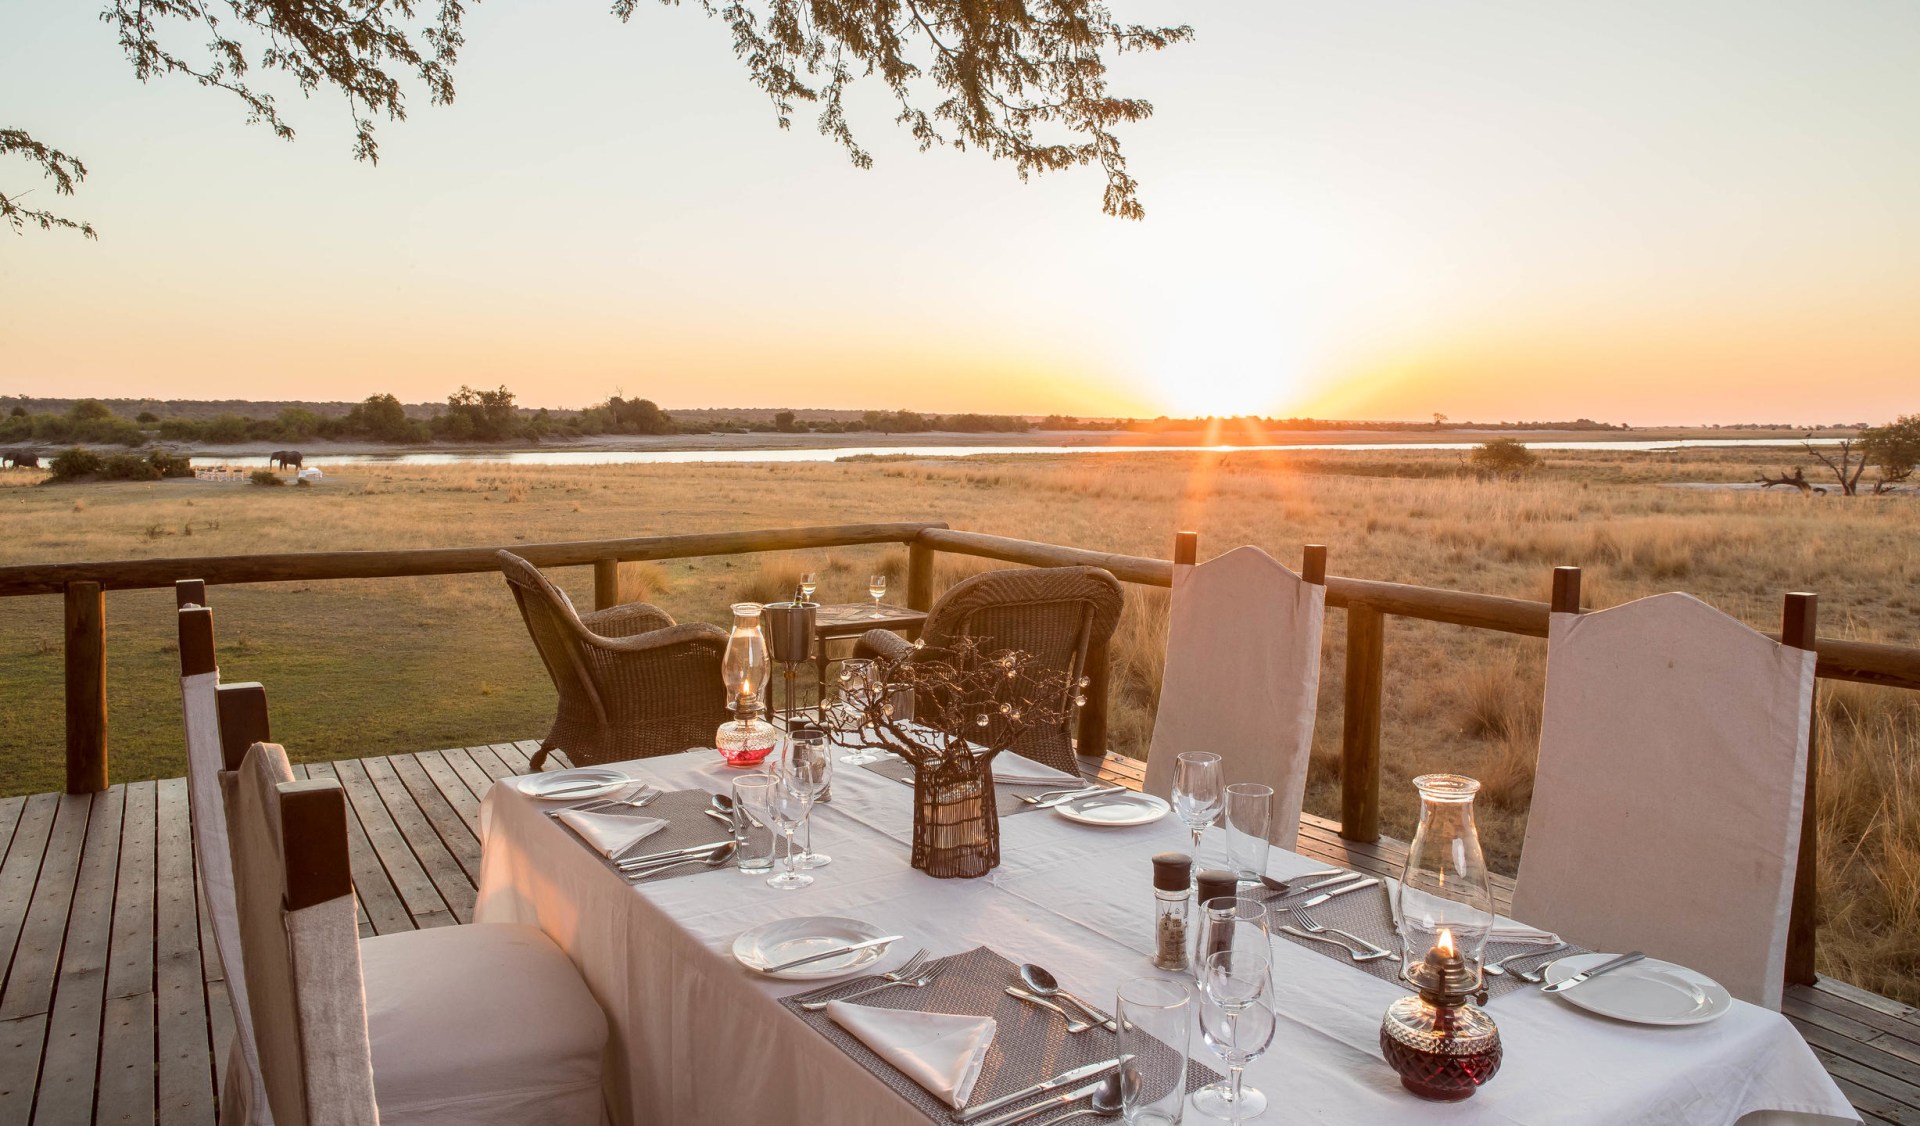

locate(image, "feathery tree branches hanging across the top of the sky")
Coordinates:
0 0 1192 238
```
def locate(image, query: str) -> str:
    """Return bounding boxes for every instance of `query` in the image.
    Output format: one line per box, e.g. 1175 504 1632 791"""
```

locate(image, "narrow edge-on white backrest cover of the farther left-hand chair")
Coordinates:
180 671 273 1126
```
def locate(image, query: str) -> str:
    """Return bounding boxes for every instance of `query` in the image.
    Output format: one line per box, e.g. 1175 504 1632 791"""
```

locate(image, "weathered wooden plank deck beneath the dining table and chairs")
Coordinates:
0 742 1920 1126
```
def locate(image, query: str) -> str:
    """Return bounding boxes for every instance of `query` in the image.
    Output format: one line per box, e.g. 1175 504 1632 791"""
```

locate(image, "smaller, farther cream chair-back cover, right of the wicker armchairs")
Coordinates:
1146 548 1327 847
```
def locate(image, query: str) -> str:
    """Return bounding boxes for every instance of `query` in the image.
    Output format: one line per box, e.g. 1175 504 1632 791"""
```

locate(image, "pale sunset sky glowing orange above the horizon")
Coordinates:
0 0 1920 423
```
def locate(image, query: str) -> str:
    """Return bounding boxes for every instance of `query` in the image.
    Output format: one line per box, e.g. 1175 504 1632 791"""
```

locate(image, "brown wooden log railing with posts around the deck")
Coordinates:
0 523 1920 982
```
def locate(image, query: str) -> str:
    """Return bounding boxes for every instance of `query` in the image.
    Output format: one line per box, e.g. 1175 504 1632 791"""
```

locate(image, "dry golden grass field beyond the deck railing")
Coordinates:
0 441 1920 1001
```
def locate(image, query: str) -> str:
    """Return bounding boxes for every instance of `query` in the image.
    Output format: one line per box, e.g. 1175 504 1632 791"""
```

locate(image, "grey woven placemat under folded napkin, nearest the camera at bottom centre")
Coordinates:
780 947 1221 1122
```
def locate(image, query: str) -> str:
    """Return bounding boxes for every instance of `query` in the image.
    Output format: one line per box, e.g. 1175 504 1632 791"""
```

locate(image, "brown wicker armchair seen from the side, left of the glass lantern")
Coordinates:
499 551 728 771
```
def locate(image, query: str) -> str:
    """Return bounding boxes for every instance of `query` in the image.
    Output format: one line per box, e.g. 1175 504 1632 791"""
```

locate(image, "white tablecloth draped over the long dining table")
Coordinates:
474 751 1859 1126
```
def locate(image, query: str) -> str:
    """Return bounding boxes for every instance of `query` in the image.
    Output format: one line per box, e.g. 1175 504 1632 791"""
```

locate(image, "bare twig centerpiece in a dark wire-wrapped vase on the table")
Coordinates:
829 638 1087 880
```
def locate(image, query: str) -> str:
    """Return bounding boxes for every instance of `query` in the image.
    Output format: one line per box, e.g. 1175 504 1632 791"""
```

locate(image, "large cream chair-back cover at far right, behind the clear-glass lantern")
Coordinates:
1513 594 1814 1009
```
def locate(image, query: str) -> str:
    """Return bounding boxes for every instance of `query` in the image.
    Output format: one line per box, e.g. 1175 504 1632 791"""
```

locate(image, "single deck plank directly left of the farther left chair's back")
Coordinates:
154 778 213 1126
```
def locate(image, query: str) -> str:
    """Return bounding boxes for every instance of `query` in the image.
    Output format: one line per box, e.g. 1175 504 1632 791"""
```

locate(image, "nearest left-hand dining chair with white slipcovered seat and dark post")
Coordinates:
230 744 607 1126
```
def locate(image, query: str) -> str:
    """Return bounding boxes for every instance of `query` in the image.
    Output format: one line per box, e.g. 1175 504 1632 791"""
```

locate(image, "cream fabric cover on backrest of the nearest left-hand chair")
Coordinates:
230 744 380 1126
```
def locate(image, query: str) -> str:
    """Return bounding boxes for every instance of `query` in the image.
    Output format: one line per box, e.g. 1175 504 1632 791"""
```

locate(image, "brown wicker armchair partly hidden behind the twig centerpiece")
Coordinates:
854 567 1121 771
